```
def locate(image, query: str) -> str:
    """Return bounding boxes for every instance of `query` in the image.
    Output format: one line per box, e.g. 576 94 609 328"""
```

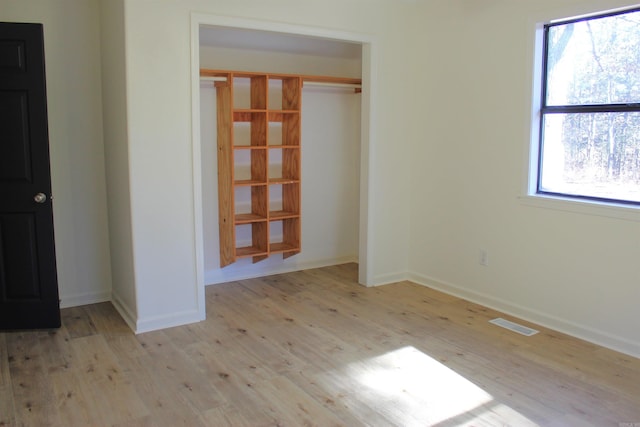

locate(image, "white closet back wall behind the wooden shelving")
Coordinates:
200 46 361 284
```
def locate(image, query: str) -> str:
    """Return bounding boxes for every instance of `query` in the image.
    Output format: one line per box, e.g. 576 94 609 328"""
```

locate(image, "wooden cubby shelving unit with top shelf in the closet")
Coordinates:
205 69 361 267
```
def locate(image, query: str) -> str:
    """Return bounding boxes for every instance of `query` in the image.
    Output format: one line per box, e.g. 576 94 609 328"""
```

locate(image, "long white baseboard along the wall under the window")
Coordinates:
407 273 640 358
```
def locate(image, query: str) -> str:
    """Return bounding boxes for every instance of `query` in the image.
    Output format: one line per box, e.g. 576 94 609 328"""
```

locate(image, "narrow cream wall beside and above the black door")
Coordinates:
0 0 111 307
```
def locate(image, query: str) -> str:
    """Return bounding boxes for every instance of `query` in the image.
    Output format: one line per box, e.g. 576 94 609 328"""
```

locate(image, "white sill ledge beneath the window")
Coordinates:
519 195 640 222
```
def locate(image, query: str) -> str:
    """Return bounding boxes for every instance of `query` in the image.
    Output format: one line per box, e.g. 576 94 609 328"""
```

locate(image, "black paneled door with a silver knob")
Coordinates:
0 23 60 330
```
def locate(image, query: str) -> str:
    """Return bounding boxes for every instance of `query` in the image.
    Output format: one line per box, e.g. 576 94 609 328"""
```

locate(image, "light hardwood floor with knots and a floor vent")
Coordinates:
0 264 640 427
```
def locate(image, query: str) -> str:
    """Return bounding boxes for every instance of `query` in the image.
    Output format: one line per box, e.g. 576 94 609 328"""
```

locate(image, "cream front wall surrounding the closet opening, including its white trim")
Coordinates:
125 0 411 330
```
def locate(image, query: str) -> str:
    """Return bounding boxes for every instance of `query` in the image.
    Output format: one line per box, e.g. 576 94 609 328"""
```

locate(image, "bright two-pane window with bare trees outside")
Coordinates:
536 10 640 205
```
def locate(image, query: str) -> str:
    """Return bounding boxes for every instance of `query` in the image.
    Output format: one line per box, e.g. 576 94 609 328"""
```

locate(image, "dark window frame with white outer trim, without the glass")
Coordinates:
535 7 640 208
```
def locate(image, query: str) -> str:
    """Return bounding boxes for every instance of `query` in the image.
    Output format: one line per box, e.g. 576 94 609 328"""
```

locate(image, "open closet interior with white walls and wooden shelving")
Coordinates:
200 28 361 283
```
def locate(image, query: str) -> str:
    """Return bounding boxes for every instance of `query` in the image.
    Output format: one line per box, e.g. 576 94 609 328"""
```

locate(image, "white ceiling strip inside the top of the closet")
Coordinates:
200 26 362 59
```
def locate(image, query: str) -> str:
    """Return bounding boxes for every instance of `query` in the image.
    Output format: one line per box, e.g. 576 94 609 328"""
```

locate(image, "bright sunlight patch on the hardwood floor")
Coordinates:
347 346 536 426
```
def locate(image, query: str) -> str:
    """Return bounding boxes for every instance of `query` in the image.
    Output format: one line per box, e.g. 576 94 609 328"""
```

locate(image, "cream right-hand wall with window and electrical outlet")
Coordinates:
409 0 640 355
